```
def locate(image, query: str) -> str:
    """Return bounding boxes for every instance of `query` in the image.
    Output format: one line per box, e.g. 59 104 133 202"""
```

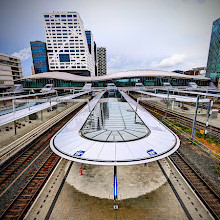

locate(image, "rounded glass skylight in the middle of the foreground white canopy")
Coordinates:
80 90 149 142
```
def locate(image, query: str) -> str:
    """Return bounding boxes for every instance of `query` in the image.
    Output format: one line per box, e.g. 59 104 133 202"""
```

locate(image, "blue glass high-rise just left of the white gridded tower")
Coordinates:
30 41 49 74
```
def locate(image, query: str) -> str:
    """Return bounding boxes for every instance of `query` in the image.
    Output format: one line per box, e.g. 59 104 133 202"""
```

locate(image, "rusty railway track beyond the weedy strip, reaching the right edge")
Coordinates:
130 94 220 139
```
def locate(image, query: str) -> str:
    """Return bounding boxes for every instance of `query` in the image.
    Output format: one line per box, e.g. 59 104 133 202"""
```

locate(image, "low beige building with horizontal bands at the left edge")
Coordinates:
0 53 23 89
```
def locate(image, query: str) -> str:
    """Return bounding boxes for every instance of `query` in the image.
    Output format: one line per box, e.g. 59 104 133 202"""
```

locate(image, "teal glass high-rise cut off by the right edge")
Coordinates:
206 18 220 83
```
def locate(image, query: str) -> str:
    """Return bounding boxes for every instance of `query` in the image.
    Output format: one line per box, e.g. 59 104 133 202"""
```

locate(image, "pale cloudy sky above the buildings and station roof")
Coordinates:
0 0 220 76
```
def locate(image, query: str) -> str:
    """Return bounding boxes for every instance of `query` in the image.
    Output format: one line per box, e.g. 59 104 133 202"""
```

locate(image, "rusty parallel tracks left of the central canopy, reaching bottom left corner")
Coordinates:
0 102 84 219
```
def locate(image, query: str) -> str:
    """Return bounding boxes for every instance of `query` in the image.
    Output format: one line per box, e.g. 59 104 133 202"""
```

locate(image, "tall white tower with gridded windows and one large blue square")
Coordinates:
44 12 95 76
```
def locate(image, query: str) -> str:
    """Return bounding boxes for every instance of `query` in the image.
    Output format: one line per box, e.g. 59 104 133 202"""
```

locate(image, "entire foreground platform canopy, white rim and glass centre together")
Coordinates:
50 90 180 165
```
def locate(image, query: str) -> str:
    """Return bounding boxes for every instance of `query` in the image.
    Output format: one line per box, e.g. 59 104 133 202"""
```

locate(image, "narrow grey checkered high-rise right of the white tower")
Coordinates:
97 47 107 76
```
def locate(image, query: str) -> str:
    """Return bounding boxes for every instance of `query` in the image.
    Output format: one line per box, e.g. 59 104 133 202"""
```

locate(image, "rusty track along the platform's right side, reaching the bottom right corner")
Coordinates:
169 151 220 219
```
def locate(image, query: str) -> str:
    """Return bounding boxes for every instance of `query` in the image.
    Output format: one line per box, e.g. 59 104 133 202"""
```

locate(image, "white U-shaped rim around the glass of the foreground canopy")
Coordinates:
50 92 180 166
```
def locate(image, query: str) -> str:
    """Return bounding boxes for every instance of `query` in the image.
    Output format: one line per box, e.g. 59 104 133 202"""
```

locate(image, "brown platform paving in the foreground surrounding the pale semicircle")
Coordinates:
25 159 212 220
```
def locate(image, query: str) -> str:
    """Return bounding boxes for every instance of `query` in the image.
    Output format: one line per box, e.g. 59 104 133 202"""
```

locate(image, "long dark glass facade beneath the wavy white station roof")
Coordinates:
21 77 210 88
